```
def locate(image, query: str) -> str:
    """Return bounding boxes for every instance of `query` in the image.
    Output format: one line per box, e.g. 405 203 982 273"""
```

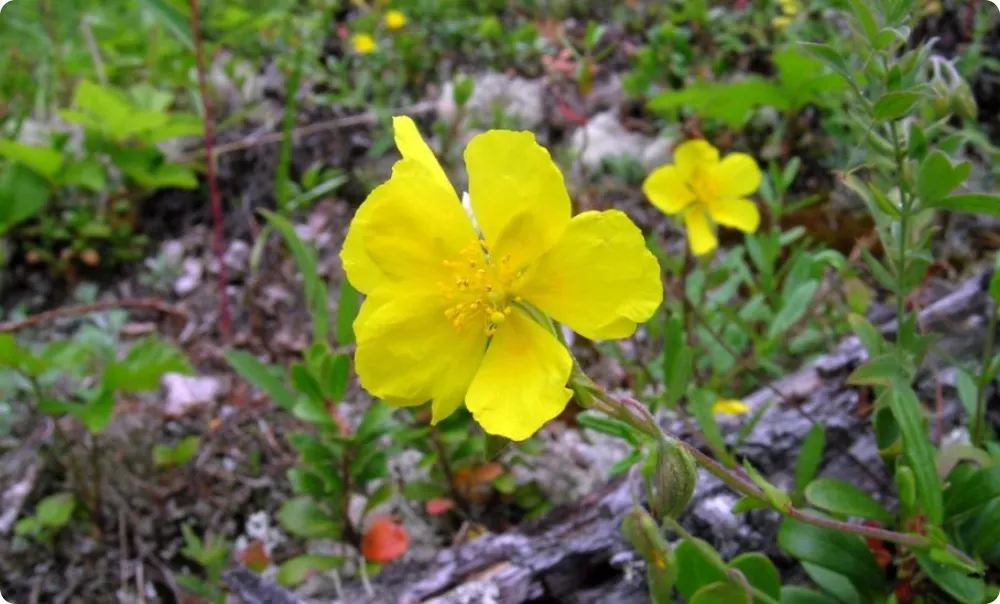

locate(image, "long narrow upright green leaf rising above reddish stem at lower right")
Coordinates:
888 382 944 524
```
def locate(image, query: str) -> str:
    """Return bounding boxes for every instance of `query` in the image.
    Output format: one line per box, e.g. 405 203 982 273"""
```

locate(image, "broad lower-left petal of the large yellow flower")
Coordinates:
355 285 486 421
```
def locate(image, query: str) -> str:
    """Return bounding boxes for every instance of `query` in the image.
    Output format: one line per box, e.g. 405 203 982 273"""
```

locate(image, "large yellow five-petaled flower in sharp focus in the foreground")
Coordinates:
341 117 663 440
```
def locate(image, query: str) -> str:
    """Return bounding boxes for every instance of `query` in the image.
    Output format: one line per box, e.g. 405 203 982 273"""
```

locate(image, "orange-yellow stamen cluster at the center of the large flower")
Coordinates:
438 241 524 336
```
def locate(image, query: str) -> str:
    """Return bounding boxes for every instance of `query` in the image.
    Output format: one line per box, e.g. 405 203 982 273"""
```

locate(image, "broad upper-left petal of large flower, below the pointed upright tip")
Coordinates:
340 170 478 294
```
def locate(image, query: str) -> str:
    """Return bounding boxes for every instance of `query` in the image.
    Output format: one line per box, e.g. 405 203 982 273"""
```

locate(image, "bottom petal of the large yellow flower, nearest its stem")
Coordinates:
465 311 573 441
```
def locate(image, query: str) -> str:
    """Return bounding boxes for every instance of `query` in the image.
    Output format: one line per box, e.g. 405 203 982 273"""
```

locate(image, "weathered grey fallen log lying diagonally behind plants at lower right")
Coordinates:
223 274 988 604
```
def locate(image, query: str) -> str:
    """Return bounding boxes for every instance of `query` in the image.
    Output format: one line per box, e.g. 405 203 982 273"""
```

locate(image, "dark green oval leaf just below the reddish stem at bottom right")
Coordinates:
778 518 885 594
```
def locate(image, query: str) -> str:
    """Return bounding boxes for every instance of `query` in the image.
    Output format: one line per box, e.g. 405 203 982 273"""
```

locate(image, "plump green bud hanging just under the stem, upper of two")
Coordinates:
645 440 698 518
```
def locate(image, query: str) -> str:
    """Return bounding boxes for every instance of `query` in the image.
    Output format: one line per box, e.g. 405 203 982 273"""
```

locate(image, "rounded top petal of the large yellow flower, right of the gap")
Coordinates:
465 130 572 266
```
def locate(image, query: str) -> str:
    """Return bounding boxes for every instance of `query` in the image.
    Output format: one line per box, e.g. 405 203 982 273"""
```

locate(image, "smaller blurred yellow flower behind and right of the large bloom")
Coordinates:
642 140 761 255
